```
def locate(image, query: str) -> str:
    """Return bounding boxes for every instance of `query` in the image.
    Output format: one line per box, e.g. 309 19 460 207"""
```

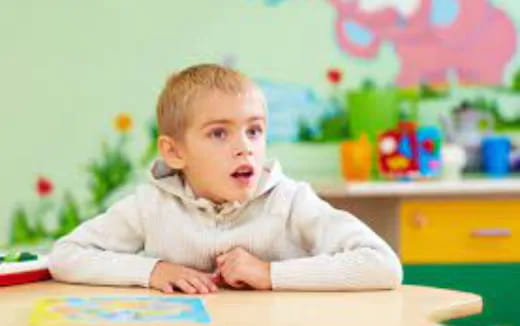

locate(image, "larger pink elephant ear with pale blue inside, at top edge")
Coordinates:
429 0 490 46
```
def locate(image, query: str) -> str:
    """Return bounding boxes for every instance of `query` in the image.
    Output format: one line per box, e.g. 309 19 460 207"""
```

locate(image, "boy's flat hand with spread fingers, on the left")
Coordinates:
150 261 217 294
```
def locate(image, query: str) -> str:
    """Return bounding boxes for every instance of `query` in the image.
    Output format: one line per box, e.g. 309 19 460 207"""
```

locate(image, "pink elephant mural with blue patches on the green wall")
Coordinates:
329 0 517 87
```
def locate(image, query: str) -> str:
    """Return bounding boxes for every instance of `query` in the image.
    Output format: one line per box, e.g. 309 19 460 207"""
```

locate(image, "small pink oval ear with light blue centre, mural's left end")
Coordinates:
336 19 380 58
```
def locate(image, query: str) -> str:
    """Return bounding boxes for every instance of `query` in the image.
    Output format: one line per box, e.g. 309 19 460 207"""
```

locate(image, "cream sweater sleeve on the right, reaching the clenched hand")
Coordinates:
271 184 403 291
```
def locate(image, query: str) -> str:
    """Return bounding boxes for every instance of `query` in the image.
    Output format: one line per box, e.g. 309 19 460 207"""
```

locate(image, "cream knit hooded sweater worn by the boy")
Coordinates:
49 160 402 290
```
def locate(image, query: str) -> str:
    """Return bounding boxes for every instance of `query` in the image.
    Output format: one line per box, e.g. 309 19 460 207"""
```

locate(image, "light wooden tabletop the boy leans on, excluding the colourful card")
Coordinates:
0 281 482 326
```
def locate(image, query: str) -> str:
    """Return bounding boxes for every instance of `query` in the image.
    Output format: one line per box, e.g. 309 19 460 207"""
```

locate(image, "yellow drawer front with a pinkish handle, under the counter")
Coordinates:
399 199 520 264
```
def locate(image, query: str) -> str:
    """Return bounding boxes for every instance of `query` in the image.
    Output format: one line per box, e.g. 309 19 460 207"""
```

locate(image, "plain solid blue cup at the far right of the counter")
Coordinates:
482 136 511 177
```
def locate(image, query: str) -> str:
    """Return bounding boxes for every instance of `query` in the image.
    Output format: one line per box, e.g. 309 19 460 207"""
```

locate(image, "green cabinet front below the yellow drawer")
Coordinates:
404 264 520 326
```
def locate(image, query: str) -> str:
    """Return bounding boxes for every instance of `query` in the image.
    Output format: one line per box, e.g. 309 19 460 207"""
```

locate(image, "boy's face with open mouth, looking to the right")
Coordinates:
174 91 266 203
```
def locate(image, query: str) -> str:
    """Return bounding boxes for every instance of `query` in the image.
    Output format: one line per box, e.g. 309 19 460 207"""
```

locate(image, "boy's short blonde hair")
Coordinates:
157 64 265 139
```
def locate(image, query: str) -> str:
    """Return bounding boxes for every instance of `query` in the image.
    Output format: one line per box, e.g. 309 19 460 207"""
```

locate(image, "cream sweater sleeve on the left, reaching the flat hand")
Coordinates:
49 188 162 287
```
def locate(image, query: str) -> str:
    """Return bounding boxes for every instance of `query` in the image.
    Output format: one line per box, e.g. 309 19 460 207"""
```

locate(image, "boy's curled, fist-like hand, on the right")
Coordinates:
217 247 271 290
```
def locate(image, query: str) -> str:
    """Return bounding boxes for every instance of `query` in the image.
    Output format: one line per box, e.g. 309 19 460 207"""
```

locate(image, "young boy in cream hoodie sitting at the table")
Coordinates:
50 64 402 294
